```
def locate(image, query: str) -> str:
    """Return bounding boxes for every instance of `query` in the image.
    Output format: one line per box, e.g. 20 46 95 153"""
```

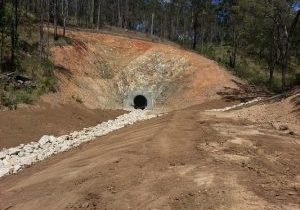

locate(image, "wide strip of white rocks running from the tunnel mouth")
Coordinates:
0 110 158 177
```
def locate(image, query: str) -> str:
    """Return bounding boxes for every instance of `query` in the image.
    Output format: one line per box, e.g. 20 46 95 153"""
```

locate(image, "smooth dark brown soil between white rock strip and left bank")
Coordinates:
0 103 124 149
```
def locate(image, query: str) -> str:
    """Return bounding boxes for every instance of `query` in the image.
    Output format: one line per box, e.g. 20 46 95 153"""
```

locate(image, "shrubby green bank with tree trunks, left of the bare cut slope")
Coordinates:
0 4 56 108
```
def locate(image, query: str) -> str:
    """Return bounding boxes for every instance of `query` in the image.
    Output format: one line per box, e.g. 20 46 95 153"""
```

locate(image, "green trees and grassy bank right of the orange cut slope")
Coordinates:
185 0 300 92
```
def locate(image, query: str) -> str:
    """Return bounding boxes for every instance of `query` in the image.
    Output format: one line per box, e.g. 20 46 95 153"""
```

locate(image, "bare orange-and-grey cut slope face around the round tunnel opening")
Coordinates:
51 31 234 109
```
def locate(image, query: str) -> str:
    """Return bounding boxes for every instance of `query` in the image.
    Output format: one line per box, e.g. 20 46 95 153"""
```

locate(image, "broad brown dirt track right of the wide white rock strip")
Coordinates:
0 101 300 210
